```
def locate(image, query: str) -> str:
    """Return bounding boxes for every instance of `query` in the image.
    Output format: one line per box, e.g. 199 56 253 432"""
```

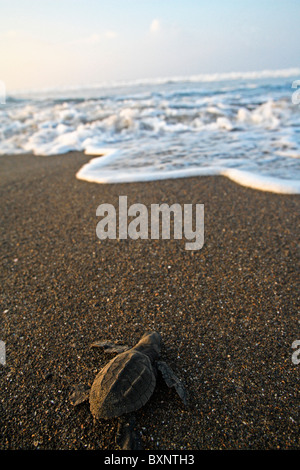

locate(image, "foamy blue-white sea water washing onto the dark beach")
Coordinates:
0 69 300 193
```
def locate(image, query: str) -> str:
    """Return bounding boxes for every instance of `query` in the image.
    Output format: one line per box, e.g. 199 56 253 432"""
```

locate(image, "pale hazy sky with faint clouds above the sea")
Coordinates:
0 0 300 91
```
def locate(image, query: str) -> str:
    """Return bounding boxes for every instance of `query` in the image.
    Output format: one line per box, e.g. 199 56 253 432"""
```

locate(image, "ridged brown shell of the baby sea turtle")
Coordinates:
89 349 156 419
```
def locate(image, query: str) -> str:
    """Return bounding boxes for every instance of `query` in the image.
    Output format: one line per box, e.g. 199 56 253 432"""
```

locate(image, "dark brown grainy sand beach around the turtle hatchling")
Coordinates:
0 152 300 450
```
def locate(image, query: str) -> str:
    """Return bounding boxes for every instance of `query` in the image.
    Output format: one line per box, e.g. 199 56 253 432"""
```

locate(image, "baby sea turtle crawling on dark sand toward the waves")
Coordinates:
71 331 187 450
